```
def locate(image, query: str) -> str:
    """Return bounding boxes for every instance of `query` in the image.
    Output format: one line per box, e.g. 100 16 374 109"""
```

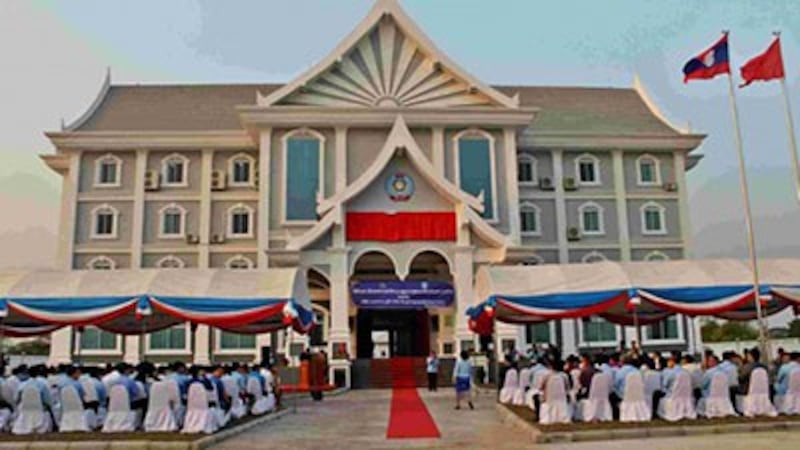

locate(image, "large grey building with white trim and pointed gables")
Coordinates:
43 0 704 386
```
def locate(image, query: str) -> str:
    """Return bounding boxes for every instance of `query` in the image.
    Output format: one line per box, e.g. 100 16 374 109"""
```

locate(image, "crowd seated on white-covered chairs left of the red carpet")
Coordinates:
0 362 280 439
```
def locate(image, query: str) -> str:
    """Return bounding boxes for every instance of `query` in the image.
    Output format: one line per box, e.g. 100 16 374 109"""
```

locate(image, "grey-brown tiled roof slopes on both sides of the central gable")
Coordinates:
70 84 677 136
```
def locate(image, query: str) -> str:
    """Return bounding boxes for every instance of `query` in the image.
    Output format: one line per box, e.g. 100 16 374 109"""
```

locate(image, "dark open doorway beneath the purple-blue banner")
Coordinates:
356 309 430 358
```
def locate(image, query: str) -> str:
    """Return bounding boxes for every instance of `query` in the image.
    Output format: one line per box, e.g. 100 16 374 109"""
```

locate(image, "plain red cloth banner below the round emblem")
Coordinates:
347 212 456 242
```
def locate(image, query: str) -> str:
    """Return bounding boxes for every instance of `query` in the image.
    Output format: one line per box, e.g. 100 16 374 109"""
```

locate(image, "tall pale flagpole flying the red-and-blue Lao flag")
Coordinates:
728 72 769 359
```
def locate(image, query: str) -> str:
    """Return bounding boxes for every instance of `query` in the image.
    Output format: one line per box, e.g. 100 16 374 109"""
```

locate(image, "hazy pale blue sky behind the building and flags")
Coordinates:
0 0 800 280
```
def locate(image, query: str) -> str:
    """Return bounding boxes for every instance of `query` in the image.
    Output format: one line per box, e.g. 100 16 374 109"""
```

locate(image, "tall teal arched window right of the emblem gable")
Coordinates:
458 139 494 219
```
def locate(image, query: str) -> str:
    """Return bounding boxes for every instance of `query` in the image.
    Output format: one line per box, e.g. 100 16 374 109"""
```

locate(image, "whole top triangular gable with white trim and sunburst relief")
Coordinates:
259 0 518 108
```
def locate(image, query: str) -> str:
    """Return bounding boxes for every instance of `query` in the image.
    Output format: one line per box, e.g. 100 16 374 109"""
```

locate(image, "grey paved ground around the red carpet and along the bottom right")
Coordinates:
214 389 800 450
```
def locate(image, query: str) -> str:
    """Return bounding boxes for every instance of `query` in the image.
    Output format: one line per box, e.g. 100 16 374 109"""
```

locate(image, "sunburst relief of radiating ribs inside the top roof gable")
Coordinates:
282 16 492 108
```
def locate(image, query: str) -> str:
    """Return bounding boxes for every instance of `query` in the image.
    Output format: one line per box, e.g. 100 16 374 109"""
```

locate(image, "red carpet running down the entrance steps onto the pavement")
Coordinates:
386 358 441 439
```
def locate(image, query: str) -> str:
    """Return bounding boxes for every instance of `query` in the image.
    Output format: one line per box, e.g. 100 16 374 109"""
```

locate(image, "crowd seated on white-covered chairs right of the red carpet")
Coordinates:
500 345 800 424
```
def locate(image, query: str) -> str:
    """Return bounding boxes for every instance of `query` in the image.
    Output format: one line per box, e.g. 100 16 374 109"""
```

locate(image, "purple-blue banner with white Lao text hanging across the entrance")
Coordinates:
350 281 455 309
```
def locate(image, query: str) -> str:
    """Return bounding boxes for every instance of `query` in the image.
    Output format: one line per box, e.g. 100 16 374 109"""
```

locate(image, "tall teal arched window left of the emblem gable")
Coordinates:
285 138 321 221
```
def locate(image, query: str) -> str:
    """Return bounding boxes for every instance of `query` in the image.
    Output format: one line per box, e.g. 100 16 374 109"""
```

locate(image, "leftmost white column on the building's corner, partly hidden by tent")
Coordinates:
47 151 81 365
